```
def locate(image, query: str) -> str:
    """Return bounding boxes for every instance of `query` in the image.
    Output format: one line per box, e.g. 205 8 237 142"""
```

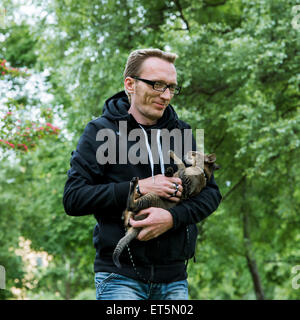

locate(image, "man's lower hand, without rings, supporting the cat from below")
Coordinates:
130 207 173 241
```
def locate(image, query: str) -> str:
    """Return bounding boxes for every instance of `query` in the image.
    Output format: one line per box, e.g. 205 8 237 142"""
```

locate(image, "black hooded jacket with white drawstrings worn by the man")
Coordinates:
63 91 222 283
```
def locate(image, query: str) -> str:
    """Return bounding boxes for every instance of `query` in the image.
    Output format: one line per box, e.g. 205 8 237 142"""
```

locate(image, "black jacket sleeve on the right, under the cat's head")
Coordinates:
169 125 222 229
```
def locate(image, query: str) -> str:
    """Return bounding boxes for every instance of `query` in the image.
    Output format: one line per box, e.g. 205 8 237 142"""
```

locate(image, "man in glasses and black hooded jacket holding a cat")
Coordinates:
63 49 221 300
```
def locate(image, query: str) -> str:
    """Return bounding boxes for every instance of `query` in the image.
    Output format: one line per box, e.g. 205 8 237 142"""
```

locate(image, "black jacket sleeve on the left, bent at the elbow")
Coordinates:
63 121 130 217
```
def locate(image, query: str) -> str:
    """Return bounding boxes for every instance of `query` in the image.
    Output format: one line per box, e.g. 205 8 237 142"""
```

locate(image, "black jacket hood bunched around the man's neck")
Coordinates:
102 91 178 130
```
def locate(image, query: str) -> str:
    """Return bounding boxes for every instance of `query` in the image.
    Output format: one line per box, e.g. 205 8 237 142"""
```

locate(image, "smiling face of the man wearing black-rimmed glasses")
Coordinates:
129 57 177 124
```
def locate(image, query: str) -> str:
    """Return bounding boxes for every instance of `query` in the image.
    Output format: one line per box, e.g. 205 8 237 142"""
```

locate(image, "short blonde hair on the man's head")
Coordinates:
123 48 178 102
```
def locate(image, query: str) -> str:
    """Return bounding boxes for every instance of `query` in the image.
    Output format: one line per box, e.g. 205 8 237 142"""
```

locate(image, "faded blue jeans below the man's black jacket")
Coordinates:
95 272 188 300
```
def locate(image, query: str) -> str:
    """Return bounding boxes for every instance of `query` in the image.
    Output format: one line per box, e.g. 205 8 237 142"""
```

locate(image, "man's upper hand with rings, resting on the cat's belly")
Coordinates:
139 174 182 202
